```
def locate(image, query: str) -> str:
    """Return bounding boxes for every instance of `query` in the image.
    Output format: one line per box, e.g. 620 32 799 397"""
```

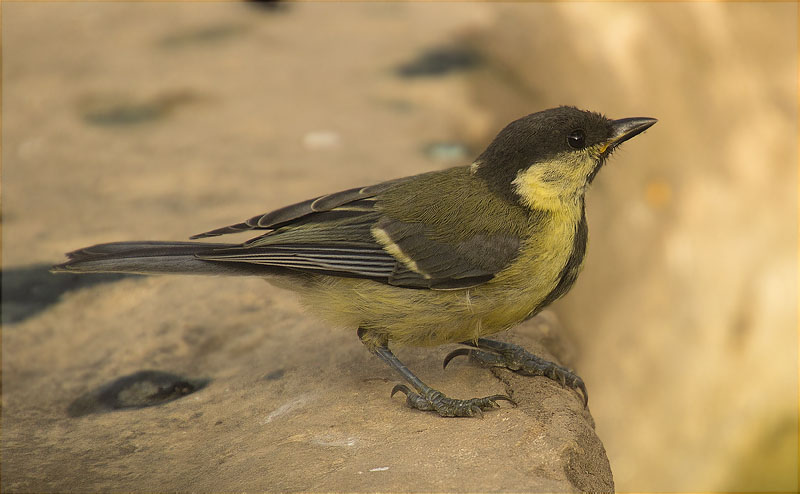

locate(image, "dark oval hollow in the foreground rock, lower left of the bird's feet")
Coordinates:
67 370 210 417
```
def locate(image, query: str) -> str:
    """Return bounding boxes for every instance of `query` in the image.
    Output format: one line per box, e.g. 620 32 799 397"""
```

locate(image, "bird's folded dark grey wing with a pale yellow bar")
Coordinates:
195 172 519 289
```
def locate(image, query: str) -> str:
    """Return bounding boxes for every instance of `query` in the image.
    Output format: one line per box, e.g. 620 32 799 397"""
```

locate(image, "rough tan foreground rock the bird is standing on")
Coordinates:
3 288 613 492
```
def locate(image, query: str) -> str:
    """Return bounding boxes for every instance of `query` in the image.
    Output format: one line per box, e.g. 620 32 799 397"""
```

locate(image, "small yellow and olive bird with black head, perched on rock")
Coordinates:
53 106 656 417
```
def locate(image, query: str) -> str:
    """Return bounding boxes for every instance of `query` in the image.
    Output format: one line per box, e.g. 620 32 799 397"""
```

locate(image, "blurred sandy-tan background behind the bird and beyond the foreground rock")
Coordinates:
2 2 798 491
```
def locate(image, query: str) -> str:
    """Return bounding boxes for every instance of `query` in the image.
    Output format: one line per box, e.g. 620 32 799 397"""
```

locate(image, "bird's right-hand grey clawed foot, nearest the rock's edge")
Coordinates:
443 338 589 407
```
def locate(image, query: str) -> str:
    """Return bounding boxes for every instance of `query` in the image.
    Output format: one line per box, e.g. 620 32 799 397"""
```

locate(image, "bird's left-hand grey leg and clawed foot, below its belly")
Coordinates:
358 329 514 417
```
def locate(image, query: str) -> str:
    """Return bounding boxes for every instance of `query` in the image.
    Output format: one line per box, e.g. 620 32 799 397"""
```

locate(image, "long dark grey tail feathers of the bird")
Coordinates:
51 242 267 276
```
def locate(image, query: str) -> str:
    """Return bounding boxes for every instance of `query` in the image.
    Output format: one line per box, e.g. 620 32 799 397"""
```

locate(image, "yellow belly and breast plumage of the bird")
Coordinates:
292 206 580 346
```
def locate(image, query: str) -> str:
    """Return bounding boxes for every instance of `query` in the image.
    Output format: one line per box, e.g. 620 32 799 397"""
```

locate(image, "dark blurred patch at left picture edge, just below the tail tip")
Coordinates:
0 264 140 326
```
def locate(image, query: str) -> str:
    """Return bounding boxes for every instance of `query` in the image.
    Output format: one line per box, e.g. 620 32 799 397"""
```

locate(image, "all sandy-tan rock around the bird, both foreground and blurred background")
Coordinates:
2 3 798 491
